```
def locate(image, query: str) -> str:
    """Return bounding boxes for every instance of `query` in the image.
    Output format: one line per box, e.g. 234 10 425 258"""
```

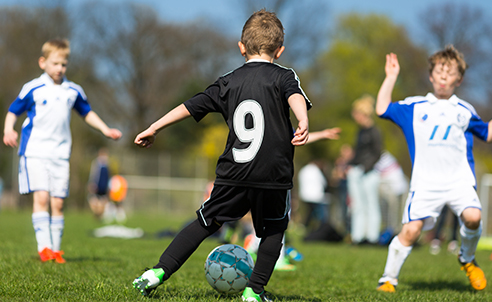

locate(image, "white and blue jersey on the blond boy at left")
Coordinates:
9 73 91 159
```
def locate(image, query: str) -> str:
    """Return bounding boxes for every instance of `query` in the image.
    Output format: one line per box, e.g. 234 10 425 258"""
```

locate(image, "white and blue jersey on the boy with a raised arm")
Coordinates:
381 93 488 191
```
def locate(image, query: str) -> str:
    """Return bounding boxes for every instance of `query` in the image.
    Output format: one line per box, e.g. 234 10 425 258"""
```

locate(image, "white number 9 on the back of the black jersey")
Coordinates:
232 100 265 163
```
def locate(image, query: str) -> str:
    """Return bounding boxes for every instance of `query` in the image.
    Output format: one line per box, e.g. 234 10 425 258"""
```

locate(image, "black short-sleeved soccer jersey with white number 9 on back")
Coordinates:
184 60 311 189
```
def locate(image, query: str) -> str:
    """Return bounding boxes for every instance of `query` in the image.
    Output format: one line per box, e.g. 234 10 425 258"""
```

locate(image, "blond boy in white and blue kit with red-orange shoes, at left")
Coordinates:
3 39 121 263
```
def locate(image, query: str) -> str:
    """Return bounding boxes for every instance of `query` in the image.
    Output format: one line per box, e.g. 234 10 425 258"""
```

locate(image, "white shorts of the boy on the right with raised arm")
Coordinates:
402 187 482 231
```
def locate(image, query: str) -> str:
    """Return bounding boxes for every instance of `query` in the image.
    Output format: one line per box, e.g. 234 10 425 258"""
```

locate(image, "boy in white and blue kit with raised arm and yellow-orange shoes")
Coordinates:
376 45 492 292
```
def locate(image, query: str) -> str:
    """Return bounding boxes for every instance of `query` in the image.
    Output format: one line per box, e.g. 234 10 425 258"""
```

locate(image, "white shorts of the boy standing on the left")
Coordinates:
19 156 70 198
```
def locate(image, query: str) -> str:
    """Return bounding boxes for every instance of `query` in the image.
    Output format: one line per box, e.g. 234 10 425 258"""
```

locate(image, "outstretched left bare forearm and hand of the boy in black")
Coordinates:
134 104 191 148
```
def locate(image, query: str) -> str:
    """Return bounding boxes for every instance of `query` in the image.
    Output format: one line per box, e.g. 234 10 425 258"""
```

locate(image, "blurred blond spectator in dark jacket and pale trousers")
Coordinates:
347 95 382 244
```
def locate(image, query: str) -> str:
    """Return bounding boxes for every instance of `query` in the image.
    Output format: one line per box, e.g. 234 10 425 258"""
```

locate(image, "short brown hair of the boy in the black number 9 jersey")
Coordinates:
241 9 284 55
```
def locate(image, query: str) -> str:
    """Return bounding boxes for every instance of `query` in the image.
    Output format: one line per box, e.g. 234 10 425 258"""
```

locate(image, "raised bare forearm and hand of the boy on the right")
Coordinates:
376 53 400 115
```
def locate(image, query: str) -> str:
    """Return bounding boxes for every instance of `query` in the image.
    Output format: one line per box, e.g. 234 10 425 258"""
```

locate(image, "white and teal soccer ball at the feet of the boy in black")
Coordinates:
205 244 255 294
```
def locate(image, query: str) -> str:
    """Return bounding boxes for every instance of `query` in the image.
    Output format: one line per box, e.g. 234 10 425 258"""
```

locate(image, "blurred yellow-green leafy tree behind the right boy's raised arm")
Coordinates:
303 14 430 167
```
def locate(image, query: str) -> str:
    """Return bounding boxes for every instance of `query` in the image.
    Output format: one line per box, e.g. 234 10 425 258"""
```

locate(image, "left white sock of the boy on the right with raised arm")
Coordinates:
379 236 413 285
